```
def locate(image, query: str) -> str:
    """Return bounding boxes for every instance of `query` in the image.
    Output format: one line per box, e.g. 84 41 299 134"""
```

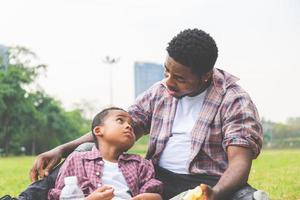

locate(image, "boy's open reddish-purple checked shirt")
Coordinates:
48 146 162 200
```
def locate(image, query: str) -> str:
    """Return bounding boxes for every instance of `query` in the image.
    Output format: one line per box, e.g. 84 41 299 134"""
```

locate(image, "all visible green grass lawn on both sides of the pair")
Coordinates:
0 146 300 200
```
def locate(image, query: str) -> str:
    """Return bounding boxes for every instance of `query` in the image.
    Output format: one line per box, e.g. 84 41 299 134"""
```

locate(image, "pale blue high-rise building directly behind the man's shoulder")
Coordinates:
134 62 164 98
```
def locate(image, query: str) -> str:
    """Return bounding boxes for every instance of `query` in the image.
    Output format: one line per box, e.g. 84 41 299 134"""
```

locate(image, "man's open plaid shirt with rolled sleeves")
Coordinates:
129 69 262 176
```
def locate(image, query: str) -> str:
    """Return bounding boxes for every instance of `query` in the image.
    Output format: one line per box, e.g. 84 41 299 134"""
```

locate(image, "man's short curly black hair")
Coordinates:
167 29 218 75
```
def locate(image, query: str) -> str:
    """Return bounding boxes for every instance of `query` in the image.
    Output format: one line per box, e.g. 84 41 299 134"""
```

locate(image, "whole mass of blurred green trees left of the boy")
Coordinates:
0 47 90 155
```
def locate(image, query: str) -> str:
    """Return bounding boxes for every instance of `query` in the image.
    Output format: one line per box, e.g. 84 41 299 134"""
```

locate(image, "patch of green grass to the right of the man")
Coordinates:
249 150 300 200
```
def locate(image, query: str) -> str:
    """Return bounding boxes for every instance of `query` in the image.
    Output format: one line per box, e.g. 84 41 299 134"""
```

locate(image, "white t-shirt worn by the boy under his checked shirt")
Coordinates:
102 159 132 200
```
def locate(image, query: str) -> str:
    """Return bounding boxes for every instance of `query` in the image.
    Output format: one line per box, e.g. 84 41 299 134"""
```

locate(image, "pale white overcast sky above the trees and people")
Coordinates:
0 0 300 122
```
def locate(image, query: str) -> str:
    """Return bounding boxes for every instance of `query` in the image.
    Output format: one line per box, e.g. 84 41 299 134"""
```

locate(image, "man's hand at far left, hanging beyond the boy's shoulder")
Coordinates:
29 148 62 182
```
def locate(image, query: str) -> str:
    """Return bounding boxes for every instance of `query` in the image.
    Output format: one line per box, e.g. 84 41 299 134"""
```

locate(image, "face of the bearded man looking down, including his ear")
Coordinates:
164 56 210 98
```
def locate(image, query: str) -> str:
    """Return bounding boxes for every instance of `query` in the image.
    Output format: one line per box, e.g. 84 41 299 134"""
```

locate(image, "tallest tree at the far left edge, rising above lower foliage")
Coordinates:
0 47 45 153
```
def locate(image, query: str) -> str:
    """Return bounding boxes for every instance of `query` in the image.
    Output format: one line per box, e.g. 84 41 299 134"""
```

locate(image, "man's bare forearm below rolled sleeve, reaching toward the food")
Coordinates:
203 146 253 200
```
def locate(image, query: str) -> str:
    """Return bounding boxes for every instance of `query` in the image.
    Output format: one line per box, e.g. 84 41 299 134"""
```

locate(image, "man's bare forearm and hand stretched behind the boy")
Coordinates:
30 132 93 182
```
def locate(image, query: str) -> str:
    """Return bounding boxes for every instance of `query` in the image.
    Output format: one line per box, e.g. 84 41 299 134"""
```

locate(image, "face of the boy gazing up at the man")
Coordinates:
99 110 136 151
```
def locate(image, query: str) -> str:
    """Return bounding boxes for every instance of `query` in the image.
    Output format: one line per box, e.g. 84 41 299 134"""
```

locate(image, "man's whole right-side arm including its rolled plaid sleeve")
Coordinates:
202 91 262 200
